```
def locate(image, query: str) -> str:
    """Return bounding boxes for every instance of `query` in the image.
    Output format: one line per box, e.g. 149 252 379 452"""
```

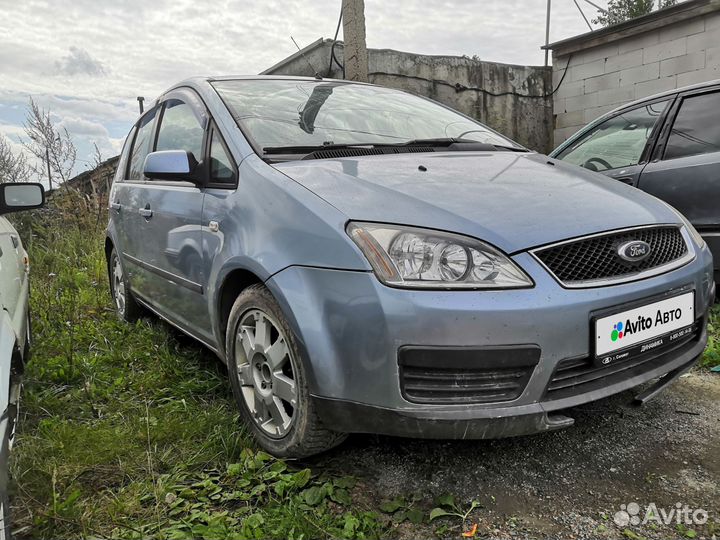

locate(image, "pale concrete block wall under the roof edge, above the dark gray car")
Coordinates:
553 12 720 146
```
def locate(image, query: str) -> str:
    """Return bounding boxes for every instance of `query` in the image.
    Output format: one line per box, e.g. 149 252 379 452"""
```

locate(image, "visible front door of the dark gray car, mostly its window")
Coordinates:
556 96 675 186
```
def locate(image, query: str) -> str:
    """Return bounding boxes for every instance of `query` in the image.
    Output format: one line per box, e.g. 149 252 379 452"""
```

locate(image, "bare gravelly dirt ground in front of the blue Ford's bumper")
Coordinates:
309 371 720 539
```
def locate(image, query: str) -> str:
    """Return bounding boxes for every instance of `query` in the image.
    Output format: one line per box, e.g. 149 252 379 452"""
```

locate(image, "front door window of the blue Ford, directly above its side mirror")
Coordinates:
155 99 205 161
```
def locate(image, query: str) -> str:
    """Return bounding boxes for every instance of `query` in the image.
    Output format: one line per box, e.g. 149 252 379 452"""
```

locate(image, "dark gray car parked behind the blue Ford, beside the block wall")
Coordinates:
550 80 720 282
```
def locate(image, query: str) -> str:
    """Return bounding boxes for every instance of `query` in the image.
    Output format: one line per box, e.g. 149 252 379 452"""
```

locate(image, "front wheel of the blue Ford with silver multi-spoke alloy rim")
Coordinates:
225 284 347 458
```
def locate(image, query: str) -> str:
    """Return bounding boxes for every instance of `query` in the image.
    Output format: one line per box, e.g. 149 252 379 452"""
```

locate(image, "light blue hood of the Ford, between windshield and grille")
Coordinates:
273 152 679 253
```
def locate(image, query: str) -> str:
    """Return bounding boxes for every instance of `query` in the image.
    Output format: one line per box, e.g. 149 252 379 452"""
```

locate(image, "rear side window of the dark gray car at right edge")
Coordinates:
665 92 720 159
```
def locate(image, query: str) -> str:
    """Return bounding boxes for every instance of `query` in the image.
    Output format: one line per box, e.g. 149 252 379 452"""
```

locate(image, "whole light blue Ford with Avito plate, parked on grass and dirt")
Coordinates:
106 77 715 456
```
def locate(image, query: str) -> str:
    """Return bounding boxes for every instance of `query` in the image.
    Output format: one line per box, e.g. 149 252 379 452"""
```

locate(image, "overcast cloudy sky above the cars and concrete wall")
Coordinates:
0 0 607 172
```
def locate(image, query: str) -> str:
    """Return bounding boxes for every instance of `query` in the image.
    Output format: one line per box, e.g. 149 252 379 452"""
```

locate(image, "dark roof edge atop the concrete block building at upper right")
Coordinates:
542 0 720 56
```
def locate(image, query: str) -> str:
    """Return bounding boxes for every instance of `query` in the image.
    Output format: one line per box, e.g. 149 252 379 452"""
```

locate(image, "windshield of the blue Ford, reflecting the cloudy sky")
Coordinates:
213 79 522 153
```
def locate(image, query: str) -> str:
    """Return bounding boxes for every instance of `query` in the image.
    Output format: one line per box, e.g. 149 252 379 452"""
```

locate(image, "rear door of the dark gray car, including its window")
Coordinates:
639 87 720 272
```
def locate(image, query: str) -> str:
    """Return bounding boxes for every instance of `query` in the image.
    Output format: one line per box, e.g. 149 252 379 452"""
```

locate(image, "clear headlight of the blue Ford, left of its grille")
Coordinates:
347 223 533 289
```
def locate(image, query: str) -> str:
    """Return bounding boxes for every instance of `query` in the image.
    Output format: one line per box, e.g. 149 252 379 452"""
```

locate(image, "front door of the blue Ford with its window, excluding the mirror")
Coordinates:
138 89 212 344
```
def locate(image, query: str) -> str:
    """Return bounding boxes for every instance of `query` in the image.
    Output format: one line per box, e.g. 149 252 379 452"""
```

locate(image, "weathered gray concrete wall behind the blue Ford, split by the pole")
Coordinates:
263 40 553 152
